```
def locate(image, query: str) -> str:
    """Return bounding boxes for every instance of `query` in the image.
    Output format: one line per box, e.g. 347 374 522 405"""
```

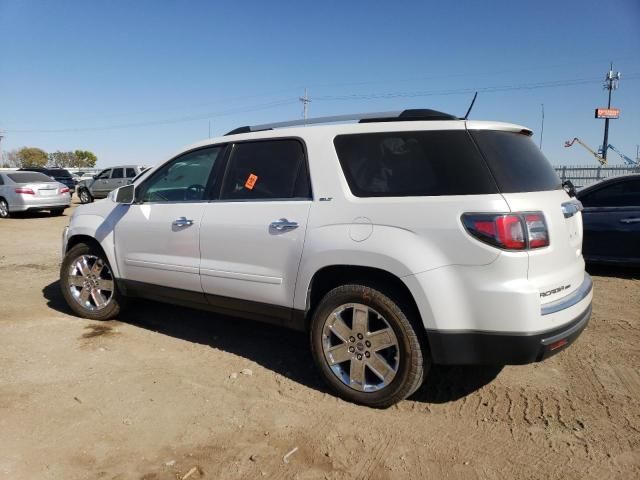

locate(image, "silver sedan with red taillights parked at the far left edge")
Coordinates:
0 171 71 218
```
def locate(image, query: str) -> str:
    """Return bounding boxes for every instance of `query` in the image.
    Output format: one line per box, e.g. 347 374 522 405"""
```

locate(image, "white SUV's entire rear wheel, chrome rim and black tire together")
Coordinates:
311 284 428 408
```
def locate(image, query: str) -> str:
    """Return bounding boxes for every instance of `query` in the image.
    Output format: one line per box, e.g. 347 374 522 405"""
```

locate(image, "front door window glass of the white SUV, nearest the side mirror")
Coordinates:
138 147 223 203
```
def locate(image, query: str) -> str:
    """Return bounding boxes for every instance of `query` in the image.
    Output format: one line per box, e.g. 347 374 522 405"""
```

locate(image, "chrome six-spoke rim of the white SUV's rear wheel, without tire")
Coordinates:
322 303 400 392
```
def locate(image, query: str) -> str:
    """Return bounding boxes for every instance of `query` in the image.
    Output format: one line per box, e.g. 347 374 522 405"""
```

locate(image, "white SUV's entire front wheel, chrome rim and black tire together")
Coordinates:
60 243 123 320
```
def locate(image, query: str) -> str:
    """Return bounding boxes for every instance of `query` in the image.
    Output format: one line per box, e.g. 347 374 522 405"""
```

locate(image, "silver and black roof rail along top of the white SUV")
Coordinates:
225 108 459 135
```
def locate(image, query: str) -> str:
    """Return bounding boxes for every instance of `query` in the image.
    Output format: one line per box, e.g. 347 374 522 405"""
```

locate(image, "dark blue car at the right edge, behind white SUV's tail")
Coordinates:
577 174 640 266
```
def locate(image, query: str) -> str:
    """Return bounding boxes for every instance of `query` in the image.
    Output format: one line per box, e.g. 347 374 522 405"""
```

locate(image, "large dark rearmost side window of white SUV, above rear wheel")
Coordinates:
334 130 497 197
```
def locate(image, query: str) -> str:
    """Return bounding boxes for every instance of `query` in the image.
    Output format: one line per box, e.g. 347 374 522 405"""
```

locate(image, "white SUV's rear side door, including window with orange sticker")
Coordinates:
200 139 311 317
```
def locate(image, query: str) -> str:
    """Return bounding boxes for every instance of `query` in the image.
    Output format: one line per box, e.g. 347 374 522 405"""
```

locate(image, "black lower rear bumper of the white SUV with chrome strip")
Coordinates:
427 274 593 365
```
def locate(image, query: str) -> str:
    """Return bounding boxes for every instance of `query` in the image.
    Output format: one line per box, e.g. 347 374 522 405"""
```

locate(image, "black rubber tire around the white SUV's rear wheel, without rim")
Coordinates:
310 284 424 408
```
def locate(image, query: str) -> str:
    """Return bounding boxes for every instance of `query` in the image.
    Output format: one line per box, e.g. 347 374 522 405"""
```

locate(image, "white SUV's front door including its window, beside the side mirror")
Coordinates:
115 146 224 302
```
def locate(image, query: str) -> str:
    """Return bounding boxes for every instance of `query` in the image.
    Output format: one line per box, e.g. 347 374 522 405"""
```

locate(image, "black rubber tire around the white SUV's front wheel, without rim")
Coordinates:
60 243 125 320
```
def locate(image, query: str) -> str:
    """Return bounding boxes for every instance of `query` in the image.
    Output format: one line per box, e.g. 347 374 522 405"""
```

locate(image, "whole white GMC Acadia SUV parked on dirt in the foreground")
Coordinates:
60 110 592 407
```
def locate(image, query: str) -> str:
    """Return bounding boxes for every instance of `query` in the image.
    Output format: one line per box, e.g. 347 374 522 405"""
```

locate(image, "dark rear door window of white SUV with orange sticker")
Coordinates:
221 140 311 200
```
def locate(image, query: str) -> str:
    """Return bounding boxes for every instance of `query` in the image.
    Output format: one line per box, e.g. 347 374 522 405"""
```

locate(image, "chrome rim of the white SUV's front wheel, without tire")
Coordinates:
68 255 113 312
